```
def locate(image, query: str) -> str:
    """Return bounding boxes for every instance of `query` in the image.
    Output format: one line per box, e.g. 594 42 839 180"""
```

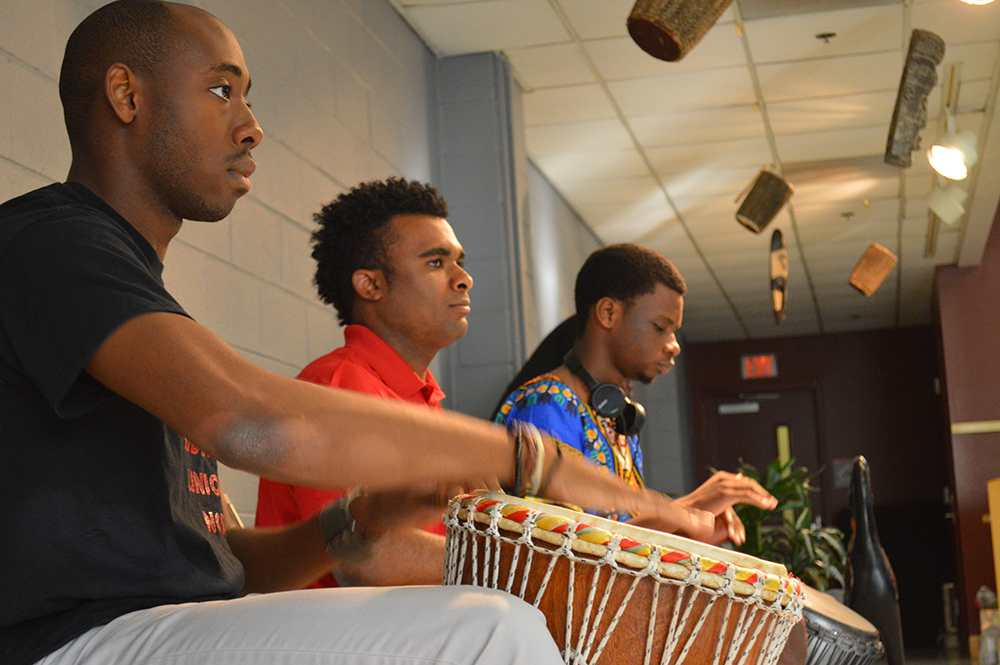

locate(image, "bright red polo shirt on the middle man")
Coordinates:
256 325 445 587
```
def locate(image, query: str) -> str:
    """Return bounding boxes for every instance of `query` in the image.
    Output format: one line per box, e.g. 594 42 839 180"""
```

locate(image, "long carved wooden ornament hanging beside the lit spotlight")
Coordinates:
885 30 944 168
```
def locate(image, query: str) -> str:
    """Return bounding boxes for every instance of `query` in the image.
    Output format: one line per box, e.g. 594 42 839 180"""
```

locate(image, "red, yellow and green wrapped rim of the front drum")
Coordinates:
449 491 804 605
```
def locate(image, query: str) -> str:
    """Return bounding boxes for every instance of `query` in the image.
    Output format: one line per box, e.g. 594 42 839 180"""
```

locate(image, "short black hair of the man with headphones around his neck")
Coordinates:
574 243 687 332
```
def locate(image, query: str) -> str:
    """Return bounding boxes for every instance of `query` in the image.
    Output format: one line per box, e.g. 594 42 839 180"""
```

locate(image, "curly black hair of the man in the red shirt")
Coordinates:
312 178 448 326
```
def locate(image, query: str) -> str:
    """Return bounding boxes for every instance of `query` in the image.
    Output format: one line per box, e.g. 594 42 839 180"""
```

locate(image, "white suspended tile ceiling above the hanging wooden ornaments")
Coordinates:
384 0 1000 341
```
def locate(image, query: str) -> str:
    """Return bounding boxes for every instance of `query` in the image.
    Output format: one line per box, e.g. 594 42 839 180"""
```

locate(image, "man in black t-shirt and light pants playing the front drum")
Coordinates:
0 0 710 665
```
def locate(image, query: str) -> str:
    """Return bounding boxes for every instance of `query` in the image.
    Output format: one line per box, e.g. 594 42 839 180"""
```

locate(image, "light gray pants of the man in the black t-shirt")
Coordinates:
38 587 562 665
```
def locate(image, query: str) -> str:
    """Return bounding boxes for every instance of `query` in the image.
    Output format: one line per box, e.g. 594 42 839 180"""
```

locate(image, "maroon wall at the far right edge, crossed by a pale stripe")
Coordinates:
935 206 1000 635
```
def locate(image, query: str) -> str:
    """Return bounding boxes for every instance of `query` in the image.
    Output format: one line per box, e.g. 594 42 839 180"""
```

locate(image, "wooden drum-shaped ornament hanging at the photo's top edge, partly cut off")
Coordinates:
628 0 733 62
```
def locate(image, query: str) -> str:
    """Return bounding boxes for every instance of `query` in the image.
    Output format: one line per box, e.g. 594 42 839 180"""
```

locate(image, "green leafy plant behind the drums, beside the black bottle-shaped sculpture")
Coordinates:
734 459 847 591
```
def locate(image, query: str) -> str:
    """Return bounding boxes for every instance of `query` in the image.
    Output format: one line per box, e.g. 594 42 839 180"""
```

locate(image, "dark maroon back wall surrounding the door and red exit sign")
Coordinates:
683 326 947 517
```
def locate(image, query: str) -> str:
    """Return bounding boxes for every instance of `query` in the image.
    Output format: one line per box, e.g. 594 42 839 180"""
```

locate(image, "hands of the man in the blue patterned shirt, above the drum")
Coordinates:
677 471 778 545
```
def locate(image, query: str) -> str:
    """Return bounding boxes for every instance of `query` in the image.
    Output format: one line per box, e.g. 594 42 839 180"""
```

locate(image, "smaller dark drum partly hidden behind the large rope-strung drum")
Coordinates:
802 584 885 665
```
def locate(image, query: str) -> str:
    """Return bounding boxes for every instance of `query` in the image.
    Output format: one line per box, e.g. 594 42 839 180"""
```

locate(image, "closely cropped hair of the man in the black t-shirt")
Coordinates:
59 0 176 145
